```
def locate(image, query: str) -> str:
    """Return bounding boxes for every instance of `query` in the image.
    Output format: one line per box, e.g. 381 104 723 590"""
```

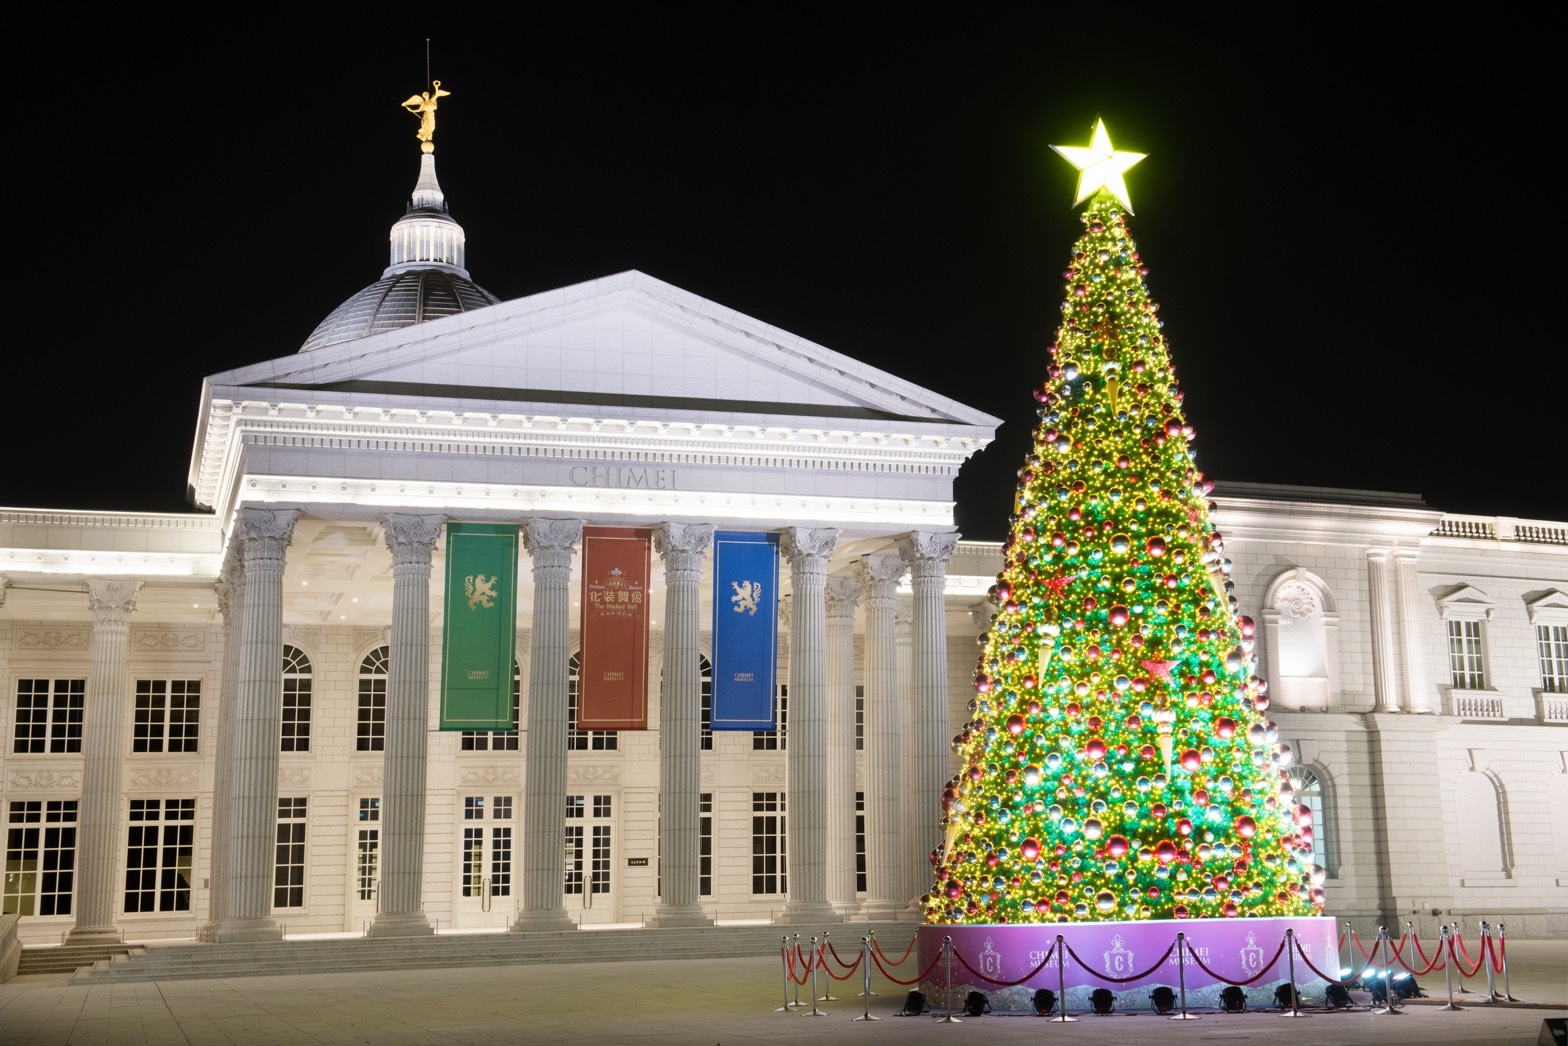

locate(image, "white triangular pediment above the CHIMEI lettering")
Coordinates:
207 271 999 430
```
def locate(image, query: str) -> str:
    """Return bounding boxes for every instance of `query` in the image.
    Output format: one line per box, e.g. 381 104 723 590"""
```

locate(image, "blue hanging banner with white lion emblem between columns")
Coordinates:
712 530 779 731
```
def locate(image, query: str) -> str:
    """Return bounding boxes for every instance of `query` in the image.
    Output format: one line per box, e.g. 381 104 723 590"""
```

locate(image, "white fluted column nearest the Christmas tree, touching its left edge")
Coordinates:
898 532 958 913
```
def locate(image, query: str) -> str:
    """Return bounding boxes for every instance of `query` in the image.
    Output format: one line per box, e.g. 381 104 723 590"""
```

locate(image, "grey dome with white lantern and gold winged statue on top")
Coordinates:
299 80 500 353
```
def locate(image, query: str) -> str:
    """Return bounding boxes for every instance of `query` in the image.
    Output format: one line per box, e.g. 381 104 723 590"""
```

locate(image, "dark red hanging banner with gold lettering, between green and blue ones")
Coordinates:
577 527 652 731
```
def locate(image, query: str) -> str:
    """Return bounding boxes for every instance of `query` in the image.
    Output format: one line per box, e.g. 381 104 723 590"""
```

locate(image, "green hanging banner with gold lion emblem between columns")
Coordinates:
441 522 517 731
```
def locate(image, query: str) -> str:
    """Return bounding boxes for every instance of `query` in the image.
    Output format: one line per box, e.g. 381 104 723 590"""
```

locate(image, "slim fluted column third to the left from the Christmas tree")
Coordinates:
826 574 861 914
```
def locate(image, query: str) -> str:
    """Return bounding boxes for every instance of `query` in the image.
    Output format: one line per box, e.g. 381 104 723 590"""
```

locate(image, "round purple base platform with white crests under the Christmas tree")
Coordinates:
916 916 1339 1013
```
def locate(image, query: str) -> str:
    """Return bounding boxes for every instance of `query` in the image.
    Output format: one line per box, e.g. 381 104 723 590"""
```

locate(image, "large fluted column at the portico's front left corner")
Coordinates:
207 508 296 941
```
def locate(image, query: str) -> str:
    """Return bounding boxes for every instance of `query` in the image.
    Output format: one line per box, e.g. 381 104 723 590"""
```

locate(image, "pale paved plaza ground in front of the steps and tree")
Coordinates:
0 938 1568 1046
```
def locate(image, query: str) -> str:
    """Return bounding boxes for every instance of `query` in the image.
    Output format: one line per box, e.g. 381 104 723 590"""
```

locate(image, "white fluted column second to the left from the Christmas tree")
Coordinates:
855 552 908 922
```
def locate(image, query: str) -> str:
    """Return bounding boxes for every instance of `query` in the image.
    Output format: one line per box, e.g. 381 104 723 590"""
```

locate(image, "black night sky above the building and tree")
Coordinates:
9 3 1568 539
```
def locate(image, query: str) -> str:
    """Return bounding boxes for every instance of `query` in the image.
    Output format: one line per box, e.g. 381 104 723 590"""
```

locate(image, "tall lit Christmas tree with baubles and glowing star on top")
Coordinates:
922 122 1322 924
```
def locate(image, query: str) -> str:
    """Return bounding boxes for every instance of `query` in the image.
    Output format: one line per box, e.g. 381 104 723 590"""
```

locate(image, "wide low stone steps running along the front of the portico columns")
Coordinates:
52 924 916 985
